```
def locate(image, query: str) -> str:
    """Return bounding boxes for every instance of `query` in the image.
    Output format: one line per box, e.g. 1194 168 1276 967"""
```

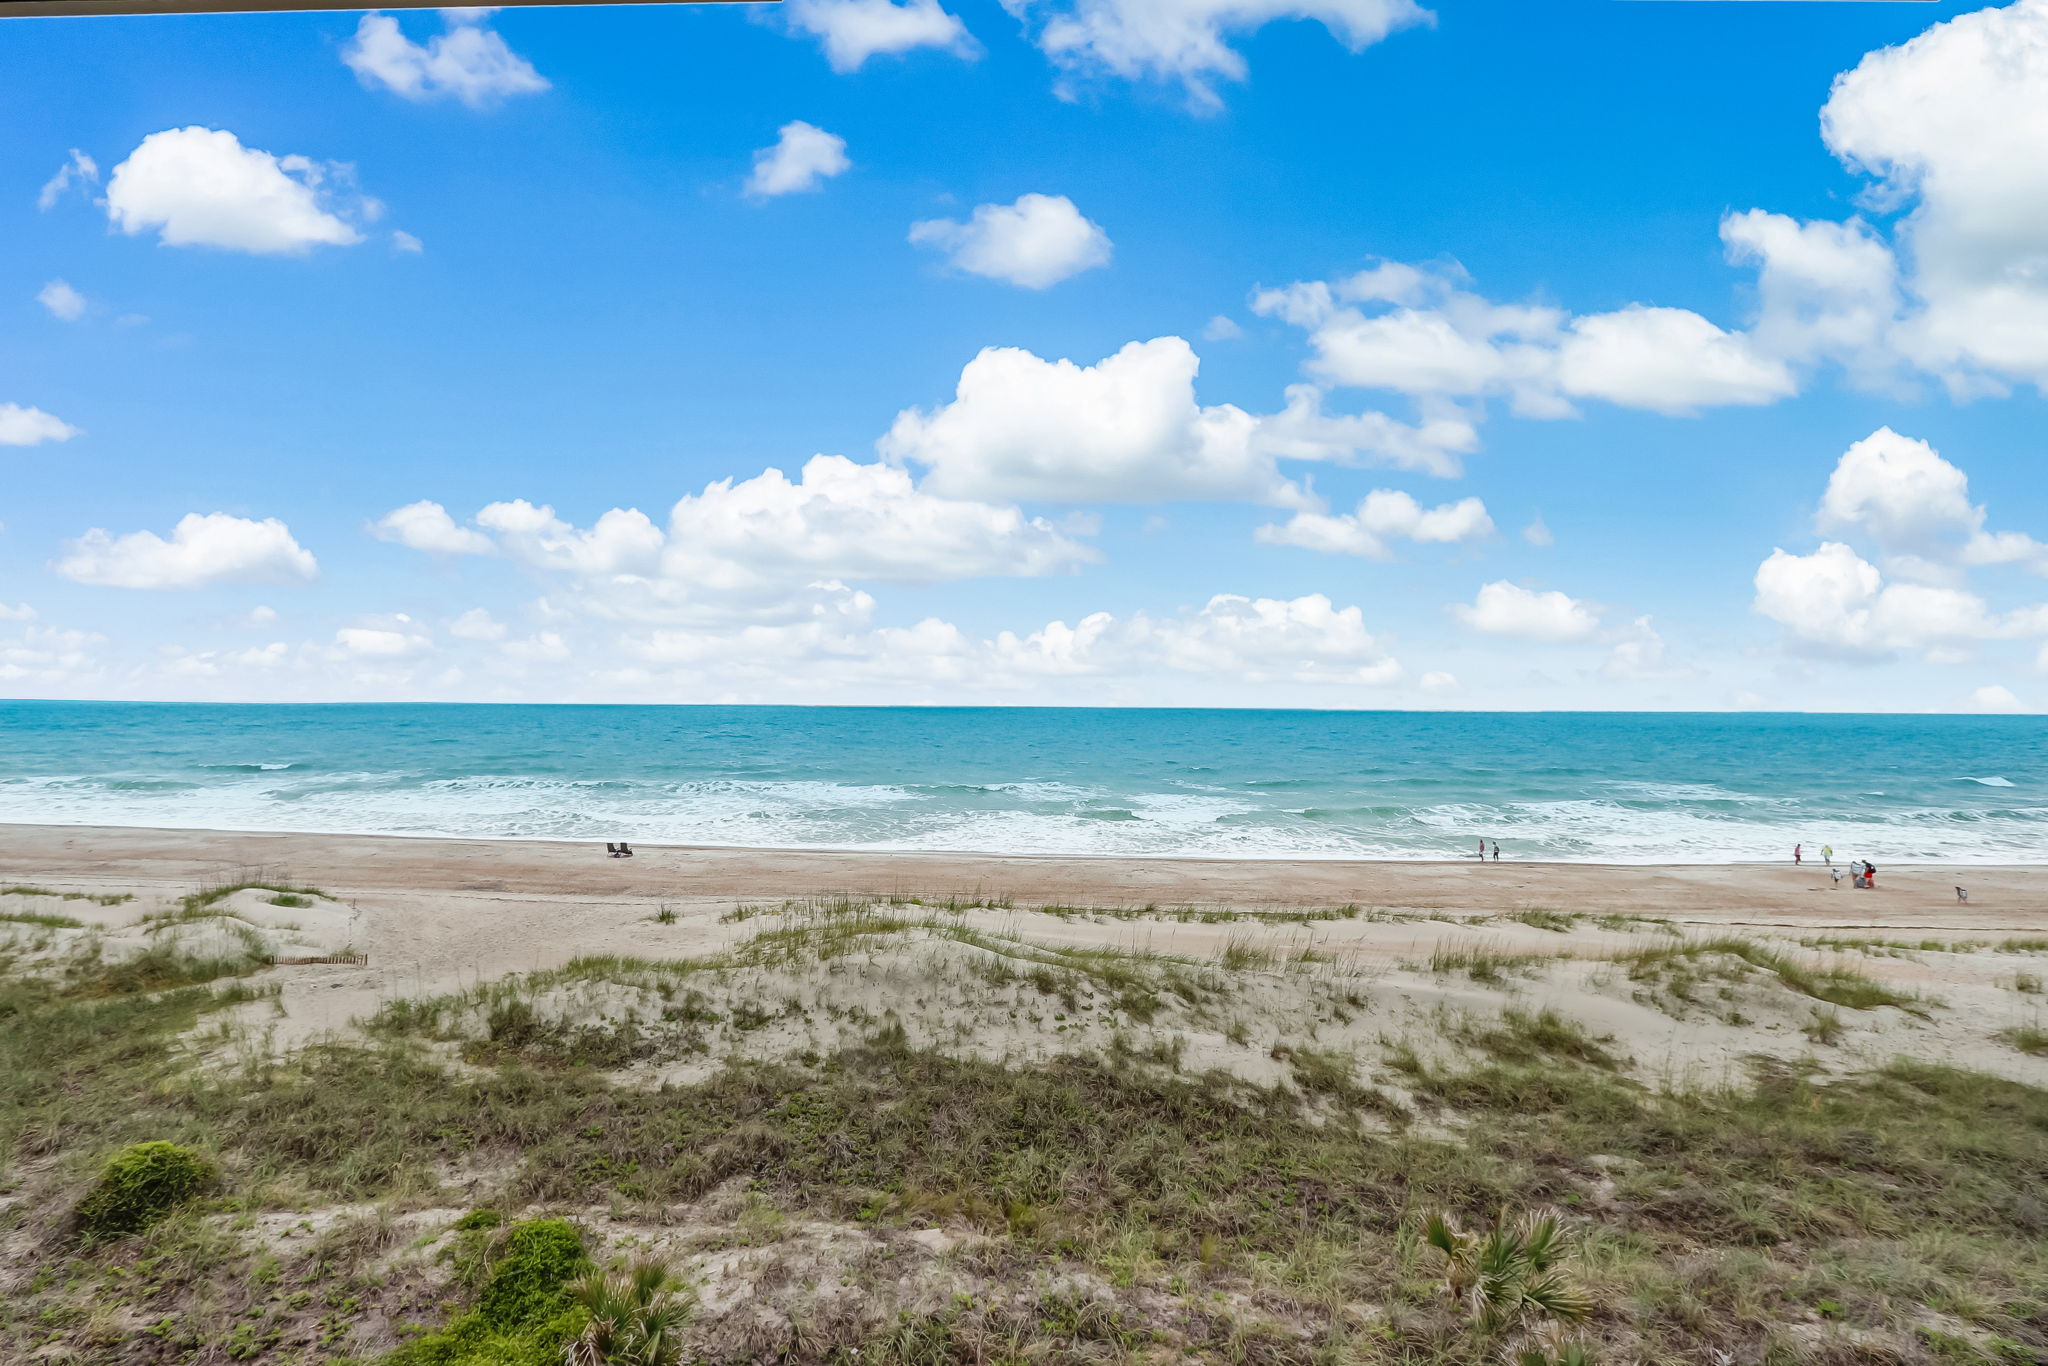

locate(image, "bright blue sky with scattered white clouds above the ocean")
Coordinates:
0 0 2048 711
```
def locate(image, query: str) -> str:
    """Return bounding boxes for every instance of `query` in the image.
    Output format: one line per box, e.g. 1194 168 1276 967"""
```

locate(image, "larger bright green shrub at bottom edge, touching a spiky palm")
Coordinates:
387 1216 590 1366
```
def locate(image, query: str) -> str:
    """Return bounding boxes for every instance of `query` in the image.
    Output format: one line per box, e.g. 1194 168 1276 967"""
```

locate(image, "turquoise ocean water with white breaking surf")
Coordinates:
0 702 2048 864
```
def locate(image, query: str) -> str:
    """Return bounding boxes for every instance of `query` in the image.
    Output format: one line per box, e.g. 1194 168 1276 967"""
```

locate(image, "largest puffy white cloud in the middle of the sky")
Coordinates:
879 336 1307 506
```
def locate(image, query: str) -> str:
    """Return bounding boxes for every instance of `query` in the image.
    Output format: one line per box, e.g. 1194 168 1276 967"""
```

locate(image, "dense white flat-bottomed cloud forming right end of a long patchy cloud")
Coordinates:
1556 303 1798 414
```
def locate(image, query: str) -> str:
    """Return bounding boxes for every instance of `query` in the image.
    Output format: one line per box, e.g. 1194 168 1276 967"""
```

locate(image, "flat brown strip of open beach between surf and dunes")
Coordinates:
0 823 2048 928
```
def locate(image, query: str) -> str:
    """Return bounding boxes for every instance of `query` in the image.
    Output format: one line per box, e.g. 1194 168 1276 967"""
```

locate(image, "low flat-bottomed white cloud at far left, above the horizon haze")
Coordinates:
51 512 319 588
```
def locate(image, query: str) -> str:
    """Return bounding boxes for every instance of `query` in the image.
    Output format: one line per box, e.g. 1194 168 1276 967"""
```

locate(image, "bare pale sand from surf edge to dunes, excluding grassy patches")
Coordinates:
0 825 2048 1083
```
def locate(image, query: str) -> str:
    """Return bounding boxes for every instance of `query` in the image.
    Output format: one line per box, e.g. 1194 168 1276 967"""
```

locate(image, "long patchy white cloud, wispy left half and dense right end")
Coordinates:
1251 262 1796 418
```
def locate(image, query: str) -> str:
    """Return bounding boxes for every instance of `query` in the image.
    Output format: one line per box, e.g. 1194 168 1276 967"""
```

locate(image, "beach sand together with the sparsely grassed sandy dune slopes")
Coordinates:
0 825 2048 1085
